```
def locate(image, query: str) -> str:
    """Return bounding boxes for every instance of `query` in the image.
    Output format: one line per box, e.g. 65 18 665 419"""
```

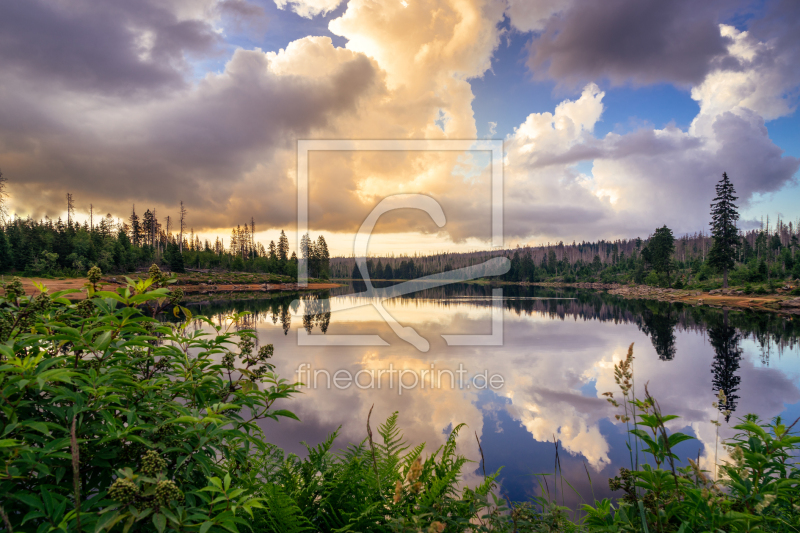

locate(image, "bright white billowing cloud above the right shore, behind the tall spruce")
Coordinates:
506 19 800 240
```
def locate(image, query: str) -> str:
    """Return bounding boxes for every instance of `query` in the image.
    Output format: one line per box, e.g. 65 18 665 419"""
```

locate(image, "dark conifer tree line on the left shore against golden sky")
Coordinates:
0 179 330 278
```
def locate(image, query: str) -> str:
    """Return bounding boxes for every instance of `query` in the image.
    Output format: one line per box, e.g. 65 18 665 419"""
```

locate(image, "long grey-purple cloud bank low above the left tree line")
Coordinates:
0 45 378 228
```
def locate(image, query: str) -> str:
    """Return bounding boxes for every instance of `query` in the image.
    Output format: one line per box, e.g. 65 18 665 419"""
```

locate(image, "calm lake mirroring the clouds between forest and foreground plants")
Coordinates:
193 284 800 504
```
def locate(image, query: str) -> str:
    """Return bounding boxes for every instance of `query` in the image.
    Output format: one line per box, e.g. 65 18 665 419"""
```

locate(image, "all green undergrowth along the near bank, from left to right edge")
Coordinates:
0 267 800 533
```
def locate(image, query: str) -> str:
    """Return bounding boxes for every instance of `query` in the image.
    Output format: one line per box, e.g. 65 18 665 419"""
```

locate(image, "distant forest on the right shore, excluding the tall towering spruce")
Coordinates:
331 221 800 286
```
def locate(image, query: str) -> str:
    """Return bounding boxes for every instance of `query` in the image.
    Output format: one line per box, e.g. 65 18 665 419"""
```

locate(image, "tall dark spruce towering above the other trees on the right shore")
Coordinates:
708 172 739 288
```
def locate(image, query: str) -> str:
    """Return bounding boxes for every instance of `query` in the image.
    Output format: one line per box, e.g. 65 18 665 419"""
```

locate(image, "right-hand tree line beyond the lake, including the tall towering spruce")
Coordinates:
331 173 800 287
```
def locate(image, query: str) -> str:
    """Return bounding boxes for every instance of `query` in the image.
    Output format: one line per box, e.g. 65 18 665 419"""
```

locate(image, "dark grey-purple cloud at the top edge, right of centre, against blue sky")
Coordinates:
528 0 734 84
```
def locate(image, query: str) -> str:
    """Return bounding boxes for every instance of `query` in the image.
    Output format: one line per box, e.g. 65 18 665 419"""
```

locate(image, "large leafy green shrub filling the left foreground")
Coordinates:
0 267 295 533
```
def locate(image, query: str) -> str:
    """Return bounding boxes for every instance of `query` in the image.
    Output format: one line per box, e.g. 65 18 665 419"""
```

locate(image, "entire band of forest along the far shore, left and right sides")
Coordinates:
0 175 800 292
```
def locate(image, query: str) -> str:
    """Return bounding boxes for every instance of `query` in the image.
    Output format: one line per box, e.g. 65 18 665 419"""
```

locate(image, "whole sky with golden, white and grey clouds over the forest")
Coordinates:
0 0 800 255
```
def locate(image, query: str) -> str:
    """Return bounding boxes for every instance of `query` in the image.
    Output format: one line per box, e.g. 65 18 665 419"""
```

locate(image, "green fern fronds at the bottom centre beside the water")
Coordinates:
253 412 506 533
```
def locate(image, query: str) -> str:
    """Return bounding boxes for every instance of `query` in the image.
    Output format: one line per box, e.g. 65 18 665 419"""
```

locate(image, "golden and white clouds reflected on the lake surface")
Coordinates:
247 295 800 474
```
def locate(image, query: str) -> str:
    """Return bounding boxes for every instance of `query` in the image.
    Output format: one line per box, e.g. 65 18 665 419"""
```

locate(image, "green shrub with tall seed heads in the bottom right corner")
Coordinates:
583 345 800 533
